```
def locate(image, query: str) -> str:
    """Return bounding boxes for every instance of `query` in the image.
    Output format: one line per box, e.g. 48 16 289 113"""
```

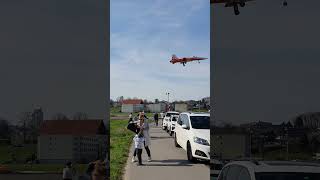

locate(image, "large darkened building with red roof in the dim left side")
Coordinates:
37 120 108 163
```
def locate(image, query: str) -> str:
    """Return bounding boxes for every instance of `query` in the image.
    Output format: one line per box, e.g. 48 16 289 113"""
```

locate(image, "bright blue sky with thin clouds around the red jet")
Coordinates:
110 0 210 100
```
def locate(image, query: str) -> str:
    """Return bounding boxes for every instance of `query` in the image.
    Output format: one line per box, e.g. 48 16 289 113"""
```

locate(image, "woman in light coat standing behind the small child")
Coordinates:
132 112 151 162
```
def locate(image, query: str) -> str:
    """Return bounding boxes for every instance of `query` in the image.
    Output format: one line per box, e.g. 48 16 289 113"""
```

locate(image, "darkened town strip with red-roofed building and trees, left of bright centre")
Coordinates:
0 107 109 167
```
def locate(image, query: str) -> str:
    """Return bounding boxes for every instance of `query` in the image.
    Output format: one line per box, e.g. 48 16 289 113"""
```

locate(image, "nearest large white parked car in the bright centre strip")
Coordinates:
174 112 210 162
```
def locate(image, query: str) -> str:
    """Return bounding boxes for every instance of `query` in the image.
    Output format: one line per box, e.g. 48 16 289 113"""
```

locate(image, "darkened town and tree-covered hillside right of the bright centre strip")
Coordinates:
211 112 320 160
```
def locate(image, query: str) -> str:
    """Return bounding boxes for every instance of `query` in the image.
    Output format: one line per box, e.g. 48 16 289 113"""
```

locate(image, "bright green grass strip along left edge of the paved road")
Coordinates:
110 120 133 180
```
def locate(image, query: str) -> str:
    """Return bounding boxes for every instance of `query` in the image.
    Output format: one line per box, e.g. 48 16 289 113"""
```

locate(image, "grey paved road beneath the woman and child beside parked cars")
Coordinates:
124 122 210 180
